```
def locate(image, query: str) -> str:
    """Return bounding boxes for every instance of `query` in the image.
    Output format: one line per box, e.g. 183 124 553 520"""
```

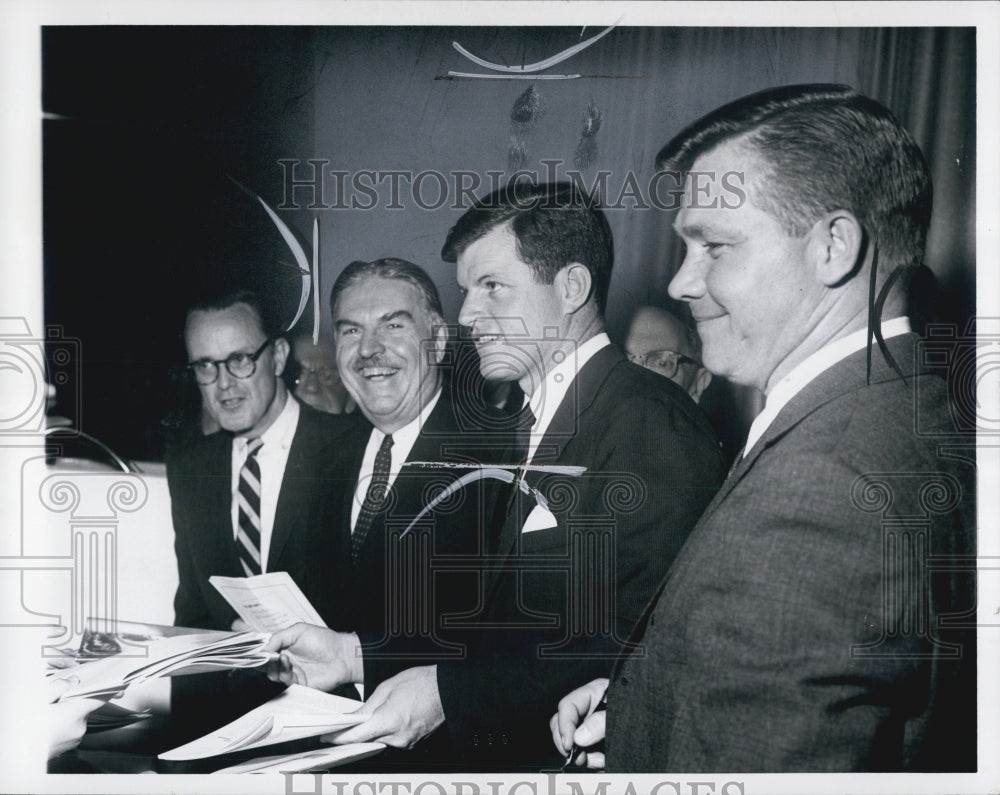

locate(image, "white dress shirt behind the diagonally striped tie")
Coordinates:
230 395 299 573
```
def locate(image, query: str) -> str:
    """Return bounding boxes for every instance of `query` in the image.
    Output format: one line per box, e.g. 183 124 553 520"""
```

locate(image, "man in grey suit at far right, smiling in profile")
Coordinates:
552 85 976 773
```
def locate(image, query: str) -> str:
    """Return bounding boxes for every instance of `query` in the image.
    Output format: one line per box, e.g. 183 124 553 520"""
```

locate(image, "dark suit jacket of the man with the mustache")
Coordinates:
317 393 510 693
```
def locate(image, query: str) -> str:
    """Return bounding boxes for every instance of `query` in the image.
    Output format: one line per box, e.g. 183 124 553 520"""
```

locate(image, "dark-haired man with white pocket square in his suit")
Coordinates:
262 183 722 769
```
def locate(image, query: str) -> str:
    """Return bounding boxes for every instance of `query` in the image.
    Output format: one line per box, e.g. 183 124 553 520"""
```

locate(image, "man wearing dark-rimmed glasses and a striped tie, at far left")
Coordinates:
167 290 353 734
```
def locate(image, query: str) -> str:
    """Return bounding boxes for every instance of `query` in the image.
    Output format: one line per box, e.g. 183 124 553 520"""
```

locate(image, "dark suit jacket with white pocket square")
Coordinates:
438 346 723 763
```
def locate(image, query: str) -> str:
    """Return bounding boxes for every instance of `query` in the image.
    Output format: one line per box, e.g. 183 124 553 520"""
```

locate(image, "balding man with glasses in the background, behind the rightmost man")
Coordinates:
624 306 712 403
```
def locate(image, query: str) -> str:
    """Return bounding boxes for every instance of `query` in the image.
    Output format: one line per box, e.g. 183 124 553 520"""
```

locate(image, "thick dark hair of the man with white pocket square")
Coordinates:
441 180 615 315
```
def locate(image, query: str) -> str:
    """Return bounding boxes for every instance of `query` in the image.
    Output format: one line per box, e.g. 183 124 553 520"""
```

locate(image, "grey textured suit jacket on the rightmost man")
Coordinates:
607 335 976 773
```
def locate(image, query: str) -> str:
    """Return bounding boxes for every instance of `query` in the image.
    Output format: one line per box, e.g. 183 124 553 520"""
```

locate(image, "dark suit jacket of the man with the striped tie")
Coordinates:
167 402 358 735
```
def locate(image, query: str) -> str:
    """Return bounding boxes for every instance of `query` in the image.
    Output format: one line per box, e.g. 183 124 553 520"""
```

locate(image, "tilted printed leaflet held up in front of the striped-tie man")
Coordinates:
208 571 326 632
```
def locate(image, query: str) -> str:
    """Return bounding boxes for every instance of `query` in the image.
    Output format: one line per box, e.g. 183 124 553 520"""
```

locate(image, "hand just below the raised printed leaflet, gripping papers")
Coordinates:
264 624 365 691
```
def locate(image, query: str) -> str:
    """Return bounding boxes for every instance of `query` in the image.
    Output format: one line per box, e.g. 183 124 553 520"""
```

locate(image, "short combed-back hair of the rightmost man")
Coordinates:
656 83 933 266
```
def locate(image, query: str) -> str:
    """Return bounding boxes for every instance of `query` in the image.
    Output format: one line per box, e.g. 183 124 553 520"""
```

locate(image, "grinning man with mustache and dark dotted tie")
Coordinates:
264 258 510 759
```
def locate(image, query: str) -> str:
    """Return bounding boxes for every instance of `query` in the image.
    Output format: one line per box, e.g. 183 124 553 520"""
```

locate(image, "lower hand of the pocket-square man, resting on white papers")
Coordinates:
322 665 444 748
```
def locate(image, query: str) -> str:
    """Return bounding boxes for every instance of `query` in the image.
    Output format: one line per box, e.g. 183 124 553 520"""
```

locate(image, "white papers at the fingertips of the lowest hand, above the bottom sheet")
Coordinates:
160 685 366 762
